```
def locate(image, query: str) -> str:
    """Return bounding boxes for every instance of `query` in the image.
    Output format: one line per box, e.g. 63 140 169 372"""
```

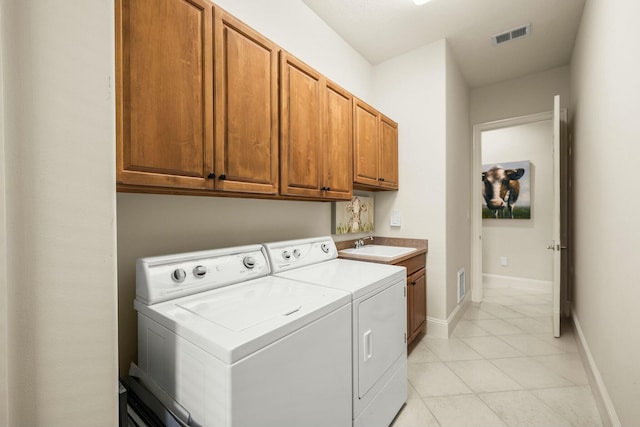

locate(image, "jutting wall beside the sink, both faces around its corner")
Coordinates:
373 40 470 337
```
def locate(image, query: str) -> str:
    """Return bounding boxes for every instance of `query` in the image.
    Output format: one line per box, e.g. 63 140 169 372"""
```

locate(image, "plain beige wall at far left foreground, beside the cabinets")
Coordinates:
0 0 117 426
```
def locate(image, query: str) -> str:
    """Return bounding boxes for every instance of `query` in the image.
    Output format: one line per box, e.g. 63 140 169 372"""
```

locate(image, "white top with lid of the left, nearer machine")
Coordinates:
135 276 351 364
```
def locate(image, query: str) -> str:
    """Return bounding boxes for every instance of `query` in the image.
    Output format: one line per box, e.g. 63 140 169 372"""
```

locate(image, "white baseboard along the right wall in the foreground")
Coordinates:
571 312 622 427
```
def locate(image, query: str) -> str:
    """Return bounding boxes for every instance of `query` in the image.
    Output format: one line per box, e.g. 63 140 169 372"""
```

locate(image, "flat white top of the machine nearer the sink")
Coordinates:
278 259 407 299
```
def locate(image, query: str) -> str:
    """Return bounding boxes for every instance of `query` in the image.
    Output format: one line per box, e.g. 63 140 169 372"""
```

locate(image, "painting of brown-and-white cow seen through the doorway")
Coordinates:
482 160 531 219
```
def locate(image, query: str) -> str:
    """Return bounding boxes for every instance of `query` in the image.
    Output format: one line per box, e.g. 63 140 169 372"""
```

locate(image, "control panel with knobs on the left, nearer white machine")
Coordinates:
136 245 269 305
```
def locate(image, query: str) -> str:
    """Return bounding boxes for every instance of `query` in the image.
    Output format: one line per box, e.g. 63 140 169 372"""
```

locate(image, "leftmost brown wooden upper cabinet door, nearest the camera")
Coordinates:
116 0 213 188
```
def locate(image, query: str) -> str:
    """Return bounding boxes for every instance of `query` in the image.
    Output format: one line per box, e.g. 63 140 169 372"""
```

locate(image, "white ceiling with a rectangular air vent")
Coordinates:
302 0 585 88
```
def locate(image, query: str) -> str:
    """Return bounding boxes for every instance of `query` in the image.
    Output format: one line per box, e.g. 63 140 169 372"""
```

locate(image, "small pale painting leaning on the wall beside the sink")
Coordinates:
331 194 373 234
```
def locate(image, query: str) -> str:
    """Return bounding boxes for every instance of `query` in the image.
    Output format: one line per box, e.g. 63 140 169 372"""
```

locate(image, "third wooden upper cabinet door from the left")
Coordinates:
280 52 324 197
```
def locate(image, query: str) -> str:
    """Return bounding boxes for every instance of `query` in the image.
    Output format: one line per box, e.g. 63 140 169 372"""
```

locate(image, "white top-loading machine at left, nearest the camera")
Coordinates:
135 245 352 427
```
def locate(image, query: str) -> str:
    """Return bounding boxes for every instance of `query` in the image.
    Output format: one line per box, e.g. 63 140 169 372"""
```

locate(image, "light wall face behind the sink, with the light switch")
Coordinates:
374 40 446 324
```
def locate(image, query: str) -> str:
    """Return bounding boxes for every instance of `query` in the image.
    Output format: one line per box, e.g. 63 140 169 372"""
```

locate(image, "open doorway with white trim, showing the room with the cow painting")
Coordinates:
471 111 553 302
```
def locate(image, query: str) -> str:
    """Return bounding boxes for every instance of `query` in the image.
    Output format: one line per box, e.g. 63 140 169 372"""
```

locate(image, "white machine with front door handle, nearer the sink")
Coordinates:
265 237 407 427
